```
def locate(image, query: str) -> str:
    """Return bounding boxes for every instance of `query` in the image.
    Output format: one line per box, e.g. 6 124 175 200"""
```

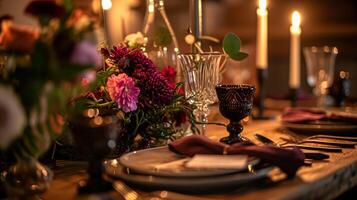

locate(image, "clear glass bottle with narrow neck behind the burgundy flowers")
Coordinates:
143 0 179 72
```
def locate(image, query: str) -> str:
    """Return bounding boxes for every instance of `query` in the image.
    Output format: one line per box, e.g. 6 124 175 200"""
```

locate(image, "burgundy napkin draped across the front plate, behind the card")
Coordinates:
169 135 305 177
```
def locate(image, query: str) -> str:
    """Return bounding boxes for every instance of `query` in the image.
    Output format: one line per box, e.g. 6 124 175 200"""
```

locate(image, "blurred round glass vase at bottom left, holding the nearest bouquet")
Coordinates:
1 157 53 199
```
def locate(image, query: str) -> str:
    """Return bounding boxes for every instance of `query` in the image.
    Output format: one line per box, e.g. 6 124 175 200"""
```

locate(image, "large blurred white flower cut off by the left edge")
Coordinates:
0 85 26 149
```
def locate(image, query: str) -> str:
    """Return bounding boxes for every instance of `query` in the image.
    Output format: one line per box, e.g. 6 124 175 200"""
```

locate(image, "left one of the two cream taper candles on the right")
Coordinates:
256 0 268 69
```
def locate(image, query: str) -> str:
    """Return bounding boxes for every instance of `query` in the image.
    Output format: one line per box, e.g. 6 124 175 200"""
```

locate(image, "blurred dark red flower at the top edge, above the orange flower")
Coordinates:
25 0 65 18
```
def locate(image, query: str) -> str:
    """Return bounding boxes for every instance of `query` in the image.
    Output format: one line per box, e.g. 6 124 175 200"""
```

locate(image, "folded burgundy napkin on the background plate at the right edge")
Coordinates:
281 108 357 123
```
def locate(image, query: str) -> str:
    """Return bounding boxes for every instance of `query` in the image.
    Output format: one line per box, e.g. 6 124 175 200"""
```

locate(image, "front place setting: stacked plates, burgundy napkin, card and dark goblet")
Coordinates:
104 85 304 193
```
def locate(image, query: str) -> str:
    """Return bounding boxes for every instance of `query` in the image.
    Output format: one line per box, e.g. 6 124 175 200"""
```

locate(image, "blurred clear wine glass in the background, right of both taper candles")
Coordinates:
304 46 338 107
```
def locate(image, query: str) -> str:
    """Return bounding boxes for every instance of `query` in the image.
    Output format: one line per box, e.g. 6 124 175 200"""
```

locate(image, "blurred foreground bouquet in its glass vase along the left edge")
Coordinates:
0 0 100 195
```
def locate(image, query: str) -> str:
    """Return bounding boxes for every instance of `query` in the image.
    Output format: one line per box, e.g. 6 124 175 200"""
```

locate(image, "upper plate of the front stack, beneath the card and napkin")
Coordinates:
111 146 259 177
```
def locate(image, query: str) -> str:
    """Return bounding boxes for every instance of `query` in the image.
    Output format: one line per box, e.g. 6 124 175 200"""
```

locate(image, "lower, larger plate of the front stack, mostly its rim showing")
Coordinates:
105 160 272 193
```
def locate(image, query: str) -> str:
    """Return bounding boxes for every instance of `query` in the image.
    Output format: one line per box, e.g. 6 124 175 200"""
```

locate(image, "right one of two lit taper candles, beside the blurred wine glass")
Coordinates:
289 11 301 89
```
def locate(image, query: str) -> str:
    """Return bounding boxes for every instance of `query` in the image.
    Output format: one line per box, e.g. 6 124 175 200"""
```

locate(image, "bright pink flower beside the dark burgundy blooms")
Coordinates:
107 73 140 112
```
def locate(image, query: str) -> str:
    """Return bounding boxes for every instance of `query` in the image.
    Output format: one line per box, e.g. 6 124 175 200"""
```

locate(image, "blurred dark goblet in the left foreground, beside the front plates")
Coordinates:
70 115 123 193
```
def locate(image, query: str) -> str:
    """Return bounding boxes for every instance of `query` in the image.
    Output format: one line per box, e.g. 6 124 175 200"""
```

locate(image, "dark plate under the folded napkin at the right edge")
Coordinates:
282 121 357 134
